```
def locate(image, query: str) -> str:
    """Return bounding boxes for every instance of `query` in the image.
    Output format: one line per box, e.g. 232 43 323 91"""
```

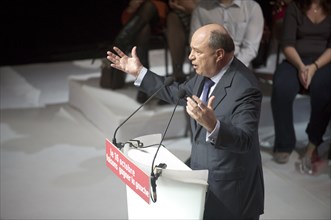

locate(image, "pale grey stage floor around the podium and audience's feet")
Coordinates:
0 51 331 219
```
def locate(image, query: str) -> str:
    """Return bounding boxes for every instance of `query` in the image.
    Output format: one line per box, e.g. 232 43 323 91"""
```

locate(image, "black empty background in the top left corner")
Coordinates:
0 0 127 66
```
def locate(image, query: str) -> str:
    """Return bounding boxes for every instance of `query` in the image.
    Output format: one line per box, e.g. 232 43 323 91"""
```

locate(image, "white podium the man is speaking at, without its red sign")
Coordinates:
123 134 208 219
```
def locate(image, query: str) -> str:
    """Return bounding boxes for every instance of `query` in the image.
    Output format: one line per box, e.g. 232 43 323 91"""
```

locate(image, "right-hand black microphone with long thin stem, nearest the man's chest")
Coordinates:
151 89 186 203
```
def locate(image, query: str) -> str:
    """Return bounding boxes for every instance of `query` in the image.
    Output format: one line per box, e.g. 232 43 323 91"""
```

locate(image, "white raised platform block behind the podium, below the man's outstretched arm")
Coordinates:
69 73 186 142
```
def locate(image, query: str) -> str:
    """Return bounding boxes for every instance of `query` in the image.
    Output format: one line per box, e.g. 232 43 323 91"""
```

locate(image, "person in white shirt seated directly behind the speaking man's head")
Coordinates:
190 0 264 66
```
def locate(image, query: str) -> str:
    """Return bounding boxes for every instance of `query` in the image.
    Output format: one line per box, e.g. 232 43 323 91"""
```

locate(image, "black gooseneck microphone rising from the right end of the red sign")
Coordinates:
151 89 186 203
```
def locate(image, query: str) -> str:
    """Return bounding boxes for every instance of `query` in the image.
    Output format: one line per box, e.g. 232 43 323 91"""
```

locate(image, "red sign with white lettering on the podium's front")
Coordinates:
106 139 150 204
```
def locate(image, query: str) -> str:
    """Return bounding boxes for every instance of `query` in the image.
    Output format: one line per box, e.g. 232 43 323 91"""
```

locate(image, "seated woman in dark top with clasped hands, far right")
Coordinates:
271 0 331 173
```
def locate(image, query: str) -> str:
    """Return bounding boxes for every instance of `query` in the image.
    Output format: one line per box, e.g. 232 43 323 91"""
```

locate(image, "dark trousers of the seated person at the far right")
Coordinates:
271 59 331 152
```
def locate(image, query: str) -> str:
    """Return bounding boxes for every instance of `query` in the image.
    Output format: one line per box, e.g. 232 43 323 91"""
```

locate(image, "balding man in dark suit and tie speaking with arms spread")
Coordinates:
107 24 264 219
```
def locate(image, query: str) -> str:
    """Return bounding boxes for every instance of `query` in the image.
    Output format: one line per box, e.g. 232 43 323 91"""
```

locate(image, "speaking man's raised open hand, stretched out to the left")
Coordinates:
107 47 143 77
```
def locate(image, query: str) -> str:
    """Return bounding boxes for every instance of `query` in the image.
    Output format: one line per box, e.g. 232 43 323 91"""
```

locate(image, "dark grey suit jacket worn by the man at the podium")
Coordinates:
140 58 264 219
